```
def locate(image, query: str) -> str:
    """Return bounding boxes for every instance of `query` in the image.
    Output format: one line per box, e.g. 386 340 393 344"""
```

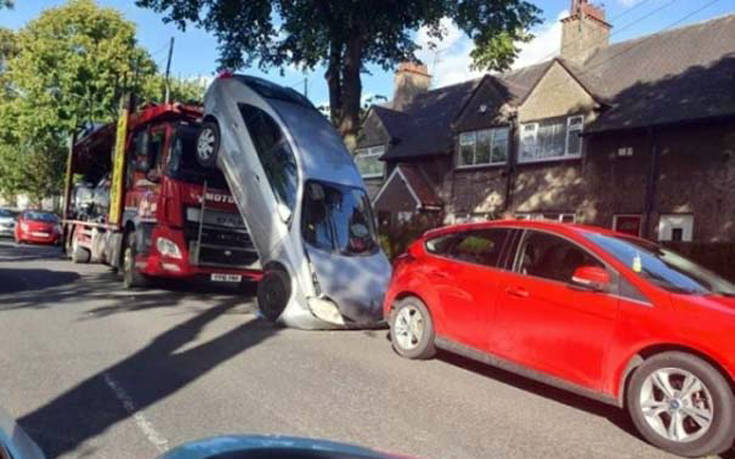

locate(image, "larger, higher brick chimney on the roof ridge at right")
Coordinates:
561 0 612 64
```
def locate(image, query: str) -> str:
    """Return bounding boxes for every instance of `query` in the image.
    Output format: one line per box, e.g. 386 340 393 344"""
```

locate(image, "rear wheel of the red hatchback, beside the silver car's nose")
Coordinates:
390 296 436 359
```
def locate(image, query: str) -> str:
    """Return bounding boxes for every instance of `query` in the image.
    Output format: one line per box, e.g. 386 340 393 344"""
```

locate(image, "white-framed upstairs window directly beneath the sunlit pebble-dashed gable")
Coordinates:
518 115 584 162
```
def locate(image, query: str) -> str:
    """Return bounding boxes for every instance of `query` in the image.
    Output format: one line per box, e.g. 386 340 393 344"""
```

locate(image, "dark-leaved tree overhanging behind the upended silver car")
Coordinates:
136 0 540 147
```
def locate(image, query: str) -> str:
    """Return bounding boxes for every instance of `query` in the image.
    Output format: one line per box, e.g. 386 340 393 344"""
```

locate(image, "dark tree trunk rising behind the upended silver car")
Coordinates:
337 33 363 151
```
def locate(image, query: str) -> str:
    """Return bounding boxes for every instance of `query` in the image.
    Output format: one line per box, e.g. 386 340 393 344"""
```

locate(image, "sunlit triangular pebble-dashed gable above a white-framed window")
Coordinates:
518 61 599 123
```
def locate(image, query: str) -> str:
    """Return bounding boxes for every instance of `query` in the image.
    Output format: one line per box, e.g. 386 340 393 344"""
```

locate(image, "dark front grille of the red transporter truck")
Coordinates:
185 209 260 269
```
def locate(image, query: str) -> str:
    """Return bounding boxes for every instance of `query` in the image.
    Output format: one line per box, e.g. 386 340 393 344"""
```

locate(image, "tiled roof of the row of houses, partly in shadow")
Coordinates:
368 15 735 156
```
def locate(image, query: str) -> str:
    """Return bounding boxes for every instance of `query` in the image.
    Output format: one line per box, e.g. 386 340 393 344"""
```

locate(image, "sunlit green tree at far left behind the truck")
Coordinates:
0 0 155 198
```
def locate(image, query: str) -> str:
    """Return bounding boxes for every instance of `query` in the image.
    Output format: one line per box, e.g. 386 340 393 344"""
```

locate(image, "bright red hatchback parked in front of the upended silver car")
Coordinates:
384 221 735 456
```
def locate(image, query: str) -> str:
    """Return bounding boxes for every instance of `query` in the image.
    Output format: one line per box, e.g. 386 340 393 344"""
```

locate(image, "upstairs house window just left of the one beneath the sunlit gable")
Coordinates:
457 127 508 167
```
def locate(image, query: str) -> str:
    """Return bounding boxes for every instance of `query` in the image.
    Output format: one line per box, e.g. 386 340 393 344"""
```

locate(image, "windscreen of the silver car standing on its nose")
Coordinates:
301 180 378 255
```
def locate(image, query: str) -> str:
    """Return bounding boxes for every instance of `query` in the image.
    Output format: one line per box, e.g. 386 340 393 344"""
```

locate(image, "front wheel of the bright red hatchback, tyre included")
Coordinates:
626 352 735 457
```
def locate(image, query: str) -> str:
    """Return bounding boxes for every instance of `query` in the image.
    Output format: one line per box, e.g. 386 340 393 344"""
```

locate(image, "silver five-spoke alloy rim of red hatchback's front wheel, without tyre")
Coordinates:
639 367 714 443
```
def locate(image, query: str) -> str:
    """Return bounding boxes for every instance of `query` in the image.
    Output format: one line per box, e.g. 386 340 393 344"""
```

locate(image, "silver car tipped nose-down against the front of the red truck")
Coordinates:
197 75 391 329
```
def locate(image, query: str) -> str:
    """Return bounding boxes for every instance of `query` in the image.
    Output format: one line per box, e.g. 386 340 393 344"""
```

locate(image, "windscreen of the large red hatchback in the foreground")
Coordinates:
585 233 735 296
